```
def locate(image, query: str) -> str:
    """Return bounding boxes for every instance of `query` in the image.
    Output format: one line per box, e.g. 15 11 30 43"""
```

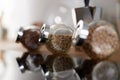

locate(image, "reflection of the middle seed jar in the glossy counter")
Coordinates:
53 56 80 80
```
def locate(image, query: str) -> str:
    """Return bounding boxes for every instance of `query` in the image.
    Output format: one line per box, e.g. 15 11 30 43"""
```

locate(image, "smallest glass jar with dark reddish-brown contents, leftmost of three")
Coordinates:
16 26 40 51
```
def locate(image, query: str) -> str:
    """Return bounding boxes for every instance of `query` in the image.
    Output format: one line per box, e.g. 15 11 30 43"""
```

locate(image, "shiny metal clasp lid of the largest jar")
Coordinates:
72 20 89 46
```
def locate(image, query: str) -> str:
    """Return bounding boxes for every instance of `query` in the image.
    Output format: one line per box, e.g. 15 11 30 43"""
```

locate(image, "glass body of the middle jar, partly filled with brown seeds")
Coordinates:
46 24 72 54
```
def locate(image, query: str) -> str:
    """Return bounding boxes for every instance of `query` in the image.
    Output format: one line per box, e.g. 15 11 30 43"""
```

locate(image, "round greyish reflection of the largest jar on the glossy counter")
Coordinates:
92 61 119 80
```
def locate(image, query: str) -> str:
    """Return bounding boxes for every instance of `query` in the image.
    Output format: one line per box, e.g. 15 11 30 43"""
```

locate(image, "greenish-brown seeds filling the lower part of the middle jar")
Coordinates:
46 34 72 54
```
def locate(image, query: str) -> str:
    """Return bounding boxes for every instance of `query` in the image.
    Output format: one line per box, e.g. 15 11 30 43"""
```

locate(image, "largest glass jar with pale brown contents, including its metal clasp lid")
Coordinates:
73 20 119 60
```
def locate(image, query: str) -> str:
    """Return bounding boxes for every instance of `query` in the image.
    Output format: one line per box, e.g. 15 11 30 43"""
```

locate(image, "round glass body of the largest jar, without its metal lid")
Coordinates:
83 21 119 60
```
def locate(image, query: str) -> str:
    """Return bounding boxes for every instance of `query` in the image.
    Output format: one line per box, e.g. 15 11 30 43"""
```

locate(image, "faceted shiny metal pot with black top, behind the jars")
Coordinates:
72 0 102 25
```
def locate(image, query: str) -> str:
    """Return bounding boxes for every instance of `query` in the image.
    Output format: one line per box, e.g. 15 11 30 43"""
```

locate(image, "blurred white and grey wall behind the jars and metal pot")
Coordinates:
0 0 116 39
